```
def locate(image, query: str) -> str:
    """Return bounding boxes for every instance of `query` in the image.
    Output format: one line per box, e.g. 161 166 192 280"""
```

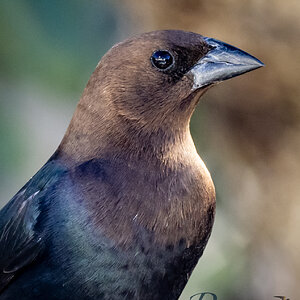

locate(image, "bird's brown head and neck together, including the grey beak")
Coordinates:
59 30 263 162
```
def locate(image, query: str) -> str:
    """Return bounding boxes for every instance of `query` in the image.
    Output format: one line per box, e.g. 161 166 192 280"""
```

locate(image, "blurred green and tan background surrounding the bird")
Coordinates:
0 0 300 300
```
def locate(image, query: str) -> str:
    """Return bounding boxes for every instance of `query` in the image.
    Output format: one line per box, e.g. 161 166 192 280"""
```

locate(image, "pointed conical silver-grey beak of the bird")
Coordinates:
187 37 264 90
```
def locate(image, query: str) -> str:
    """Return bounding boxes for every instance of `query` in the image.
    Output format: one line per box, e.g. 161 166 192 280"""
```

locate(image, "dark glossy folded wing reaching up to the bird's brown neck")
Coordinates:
0 159 65 293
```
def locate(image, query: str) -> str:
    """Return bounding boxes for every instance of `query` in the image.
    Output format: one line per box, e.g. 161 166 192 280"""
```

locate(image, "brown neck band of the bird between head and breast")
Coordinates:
57 101 197 166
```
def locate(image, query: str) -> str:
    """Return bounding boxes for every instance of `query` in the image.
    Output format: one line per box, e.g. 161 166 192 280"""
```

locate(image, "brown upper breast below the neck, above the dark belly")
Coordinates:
70 158 215 248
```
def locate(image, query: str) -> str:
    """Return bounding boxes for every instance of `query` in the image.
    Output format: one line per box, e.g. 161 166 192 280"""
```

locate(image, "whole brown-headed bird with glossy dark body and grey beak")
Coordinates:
0 30 263 300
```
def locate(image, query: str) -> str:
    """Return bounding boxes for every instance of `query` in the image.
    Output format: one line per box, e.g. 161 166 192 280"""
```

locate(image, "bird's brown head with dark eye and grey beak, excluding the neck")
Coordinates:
60 30 263 161
